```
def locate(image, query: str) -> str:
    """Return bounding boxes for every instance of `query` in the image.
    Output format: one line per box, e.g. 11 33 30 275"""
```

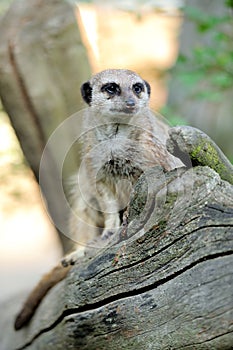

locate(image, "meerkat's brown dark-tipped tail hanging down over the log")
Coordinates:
14 265 71 330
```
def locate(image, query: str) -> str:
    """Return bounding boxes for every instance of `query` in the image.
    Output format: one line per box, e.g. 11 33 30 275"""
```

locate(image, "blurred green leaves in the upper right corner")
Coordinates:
172 0 233 102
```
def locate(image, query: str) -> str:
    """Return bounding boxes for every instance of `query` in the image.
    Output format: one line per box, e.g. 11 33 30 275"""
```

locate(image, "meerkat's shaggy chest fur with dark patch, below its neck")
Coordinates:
87 125 158 186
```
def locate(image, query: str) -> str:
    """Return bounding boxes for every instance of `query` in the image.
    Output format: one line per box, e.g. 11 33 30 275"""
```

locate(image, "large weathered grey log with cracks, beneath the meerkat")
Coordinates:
0 161 233 350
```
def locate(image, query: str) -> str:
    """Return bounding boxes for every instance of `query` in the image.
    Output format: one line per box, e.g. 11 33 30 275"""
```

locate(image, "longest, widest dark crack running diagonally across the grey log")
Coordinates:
15 250 233 350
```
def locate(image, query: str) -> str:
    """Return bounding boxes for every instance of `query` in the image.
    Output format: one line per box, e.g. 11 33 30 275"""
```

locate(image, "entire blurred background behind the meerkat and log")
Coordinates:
0 0 233 301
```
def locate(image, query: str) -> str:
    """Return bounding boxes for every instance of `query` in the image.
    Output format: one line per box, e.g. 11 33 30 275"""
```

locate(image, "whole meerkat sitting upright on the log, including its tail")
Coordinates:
15 69 181 329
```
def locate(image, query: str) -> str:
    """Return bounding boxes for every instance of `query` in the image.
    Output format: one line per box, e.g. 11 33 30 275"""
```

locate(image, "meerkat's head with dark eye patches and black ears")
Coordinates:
81 69 150 116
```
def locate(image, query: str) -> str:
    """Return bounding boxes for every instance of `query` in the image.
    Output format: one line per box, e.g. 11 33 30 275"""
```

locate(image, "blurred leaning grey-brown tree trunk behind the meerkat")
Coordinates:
0 0 91 252
